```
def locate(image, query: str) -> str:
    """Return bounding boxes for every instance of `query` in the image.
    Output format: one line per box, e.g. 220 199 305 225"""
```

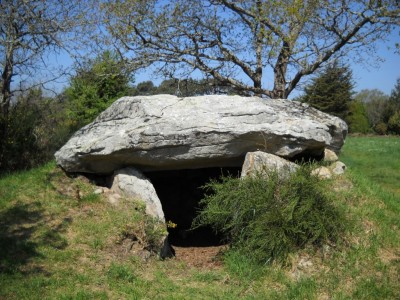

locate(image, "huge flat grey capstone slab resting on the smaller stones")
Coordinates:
55 95 347 174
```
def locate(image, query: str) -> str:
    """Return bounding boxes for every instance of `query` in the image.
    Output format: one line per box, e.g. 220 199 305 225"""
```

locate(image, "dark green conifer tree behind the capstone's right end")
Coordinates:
300 61 353 119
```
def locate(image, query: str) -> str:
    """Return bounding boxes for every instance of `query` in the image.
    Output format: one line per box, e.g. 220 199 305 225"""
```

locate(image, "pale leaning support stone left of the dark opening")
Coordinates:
111 168 165 222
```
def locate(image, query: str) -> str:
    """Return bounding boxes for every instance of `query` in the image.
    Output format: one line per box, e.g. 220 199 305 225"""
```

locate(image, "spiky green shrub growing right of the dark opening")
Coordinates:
194 165 346 263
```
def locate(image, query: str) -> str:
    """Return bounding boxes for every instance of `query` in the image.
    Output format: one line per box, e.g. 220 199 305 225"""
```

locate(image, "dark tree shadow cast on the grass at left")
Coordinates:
0 202 67 274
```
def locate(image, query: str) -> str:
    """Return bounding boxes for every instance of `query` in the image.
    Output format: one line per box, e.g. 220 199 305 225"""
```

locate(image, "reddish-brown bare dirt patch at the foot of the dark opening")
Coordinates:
174 245 227 269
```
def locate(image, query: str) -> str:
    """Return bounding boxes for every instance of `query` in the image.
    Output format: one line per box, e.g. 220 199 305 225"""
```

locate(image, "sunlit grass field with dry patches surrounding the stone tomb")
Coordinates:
0 137 400 299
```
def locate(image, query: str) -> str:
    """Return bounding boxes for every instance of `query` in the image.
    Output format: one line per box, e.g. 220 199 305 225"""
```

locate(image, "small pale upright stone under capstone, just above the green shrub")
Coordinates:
240 151 299 178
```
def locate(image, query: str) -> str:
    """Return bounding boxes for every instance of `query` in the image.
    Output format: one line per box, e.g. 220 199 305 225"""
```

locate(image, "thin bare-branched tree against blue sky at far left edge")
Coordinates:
0 0 88 118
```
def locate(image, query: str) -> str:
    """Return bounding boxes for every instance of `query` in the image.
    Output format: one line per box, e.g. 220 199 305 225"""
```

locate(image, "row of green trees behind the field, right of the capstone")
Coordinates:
295 61 400 135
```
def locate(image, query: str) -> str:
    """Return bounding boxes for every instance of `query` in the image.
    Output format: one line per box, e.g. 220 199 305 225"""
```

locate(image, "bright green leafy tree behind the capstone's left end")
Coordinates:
65 51 132 129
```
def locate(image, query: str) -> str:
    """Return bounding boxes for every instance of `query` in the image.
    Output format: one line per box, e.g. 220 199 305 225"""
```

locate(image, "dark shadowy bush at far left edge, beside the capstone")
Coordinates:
0 89 71 173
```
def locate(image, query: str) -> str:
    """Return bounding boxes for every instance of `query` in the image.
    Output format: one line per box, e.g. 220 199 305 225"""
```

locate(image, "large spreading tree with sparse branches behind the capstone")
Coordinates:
101 0 400 98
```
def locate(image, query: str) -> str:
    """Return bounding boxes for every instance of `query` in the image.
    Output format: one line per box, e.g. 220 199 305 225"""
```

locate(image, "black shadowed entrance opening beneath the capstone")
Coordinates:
145 167 241 247
